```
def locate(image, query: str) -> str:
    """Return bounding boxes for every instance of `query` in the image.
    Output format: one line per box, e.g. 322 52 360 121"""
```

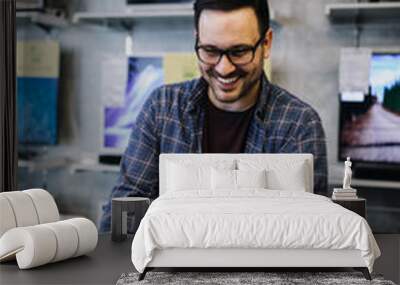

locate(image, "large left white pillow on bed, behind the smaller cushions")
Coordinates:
166 160 235 191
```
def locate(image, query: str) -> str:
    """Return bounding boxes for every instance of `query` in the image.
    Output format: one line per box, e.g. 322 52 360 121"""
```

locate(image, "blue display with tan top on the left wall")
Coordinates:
16 39 60 145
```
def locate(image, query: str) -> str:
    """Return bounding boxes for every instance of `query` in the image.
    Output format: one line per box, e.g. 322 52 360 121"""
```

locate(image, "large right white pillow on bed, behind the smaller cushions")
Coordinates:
238 159 310 192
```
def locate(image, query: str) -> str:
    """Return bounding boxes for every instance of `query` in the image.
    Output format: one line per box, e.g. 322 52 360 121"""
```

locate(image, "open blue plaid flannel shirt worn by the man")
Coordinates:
100 75 327 231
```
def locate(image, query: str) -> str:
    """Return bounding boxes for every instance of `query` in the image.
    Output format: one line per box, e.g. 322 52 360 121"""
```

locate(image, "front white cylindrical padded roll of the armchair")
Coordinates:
0 218 98 269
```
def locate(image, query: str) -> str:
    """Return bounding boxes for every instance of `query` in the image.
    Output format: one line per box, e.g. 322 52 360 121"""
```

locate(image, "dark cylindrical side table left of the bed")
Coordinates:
111 197 150 241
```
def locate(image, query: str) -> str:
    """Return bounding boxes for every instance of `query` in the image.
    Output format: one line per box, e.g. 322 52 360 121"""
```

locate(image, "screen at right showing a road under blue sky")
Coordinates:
339 53 400 164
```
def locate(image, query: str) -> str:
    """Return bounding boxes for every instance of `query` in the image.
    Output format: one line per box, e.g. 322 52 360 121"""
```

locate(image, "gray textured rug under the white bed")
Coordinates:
117 272 395 285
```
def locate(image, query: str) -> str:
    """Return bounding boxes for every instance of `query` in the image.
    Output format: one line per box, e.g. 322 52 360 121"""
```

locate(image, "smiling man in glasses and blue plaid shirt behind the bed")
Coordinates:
101 0 327 231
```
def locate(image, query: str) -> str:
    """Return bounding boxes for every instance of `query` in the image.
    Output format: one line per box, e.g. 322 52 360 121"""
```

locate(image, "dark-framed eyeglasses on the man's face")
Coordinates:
195 37 265 65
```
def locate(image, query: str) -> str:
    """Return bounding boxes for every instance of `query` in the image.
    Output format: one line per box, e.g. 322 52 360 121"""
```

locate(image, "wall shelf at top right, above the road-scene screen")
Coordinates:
325 2 400 23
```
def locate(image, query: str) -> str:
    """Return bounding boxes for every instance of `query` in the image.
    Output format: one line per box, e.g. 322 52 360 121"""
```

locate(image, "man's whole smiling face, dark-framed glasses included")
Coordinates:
196 4 272 112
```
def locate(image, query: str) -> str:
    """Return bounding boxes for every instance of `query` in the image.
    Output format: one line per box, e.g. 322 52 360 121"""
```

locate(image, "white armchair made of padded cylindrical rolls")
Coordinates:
0 189 98 269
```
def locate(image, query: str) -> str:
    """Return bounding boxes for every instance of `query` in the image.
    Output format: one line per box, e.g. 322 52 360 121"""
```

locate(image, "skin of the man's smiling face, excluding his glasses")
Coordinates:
198 7 272 109
